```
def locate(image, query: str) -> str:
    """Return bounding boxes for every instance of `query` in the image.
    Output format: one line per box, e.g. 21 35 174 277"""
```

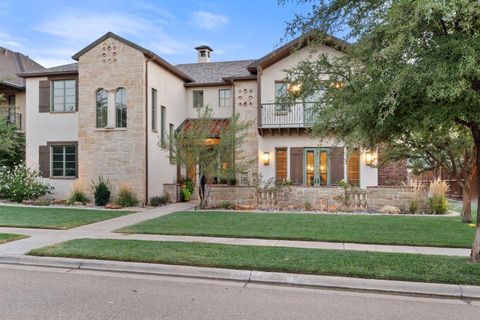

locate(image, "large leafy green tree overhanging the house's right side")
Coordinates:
280 0 480 262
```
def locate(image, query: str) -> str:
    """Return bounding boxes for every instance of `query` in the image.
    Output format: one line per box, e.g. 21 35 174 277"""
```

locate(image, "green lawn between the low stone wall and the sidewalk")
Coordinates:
117 211 475 248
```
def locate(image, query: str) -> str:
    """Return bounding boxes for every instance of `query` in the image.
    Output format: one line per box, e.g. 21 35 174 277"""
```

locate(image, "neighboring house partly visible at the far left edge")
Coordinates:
0 47 44 130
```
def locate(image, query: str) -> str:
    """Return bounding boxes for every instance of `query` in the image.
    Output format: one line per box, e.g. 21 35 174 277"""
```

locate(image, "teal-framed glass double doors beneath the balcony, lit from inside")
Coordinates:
304 148 330 187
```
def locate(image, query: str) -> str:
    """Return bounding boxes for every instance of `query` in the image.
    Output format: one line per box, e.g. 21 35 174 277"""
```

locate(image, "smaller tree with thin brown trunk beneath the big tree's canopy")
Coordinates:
382 125 475 223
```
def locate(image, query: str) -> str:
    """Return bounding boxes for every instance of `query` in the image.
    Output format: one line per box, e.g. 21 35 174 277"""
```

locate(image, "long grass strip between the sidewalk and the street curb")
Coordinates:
29 239 480 285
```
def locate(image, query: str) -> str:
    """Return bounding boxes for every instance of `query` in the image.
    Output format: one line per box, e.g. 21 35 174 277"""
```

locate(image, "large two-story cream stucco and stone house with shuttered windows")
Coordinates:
20 33 407 201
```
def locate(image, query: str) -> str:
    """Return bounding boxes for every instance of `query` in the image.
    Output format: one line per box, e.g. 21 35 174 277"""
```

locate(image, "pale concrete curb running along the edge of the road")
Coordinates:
0 255 480 300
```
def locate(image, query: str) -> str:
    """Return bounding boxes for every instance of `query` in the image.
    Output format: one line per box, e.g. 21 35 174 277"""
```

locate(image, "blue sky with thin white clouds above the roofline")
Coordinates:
0 0 309 67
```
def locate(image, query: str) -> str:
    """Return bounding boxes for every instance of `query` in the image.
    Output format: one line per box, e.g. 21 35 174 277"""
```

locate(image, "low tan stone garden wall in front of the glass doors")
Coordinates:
202 185 427 213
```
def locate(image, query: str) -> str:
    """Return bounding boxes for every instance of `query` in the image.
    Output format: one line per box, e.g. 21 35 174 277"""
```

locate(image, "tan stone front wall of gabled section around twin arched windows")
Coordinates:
78 38 145 200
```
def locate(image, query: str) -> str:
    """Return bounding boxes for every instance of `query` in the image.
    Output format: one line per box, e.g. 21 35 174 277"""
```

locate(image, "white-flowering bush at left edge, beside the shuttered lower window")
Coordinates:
0 163 53 202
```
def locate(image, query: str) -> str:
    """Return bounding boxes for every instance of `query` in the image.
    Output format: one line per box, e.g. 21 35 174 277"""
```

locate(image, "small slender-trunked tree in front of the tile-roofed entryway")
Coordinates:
171 106 251 208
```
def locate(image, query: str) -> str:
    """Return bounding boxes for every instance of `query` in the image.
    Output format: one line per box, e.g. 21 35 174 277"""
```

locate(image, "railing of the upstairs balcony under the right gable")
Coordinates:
259 102 315 128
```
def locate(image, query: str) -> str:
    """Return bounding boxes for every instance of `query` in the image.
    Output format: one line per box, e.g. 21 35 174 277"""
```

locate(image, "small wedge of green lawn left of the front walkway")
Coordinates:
0 206 130 229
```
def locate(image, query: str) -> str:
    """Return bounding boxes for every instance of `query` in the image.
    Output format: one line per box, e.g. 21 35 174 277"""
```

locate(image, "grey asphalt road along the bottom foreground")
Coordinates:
0 265 480 320
